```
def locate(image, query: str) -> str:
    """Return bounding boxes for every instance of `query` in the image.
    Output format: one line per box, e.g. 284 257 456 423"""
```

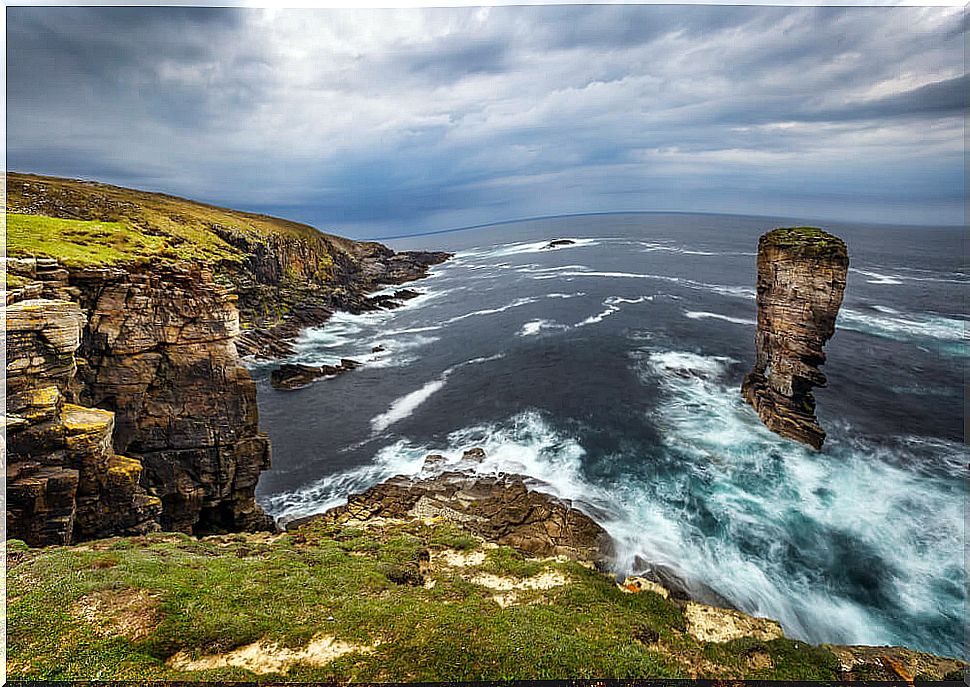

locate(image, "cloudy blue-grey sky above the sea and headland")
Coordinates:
6 5 968 238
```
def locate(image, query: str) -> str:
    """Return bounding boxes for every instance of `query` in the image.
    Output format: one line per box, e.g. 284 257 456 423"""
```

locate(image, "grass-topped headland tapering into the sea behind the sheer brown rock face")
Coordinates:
7 173 449 358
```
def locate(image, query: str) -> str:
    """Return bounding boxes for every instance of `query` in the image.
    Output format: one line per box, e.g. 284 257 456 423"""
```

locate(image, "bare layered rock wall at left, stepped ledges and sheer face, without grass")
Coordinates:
7 264 274 545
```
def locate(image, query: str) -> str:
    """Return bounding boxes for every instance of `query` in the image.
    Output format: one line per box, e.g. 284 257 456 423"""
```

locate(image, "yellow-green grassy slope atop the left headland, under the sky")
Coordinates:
7 173 353 266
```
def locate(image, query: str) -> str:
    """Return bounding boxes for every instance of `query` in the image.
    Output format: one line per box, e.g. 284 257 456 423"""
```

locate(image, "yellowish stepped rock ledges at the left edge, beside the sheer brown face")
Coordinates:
5 299 162 546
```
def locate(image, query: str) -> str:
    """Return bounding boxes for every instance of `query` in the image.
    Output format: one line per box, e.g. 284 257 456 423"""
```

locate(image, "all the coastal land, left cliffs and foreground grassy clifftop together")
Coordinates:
6 174 965 682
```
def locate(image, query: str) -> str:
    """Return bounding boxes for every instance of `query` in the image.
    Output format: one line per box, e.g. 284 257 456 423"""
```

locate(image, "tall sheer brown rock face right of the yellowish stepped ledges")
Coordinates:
70 265 272 533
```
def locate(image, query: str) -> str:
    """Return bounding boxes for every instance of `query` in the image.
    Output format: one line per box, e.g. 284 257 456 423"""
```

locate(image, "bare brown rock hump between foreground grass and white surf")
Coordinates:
288 449 612 560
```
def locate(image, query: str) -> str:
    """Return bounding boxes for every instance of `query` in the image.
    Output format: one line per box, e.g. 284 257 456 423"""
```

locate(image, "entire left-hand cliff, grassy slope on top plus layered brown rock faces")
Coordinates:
5 174 447 545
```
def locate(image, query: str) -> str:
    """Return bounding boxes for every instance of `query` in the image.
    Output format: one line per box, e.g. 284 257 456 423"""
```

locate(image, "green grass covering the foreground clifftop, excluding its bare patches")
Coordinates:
7 523 834 681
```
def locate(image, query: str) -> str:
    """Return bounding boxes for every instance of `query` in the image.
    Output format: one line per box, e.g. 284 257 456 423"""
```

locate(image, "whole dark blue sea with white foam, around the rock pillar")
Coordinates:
256 214 970 655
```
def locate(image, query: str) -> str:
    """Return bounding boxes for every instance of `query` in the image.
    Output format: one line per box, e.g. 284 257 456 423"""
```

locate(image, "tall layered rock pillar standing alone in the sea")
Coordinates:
741 227 849 450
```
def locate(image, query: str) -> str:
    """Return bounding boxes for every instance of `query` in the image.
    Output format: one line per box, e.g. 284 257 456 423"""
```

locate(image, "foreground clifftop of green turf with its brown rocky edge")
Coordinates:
7 449 965 683
